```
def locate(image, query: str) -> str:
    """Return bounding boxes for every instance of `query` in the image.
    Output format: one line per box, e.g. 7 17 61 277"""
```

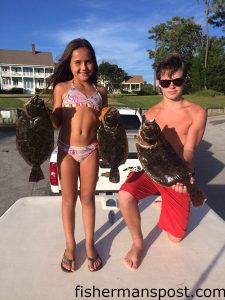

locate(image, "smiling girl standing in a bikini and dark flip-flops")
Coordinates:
48 39 107 272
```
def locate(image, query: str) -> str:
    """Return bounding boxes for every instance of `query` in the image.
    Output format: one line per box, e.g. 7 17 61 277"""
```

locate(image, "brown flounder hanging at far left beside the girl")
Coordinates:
16 95 54 182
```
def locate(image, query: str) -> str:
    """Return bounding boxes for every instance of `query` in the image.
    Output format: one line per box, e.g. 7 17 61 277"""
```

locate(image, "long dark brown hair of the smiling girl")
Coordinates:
48 38 98 89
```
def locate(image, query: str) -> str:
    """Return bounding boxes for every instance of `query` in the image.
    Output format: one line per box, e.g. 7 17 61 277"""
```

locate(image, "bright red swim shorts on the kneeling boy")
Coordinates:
120 170 190 238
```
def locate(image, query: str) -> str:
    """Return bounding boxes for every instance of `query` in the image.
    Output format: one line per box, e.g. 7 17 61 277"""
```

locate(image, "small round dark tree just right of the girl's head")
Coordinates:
98 61 127 93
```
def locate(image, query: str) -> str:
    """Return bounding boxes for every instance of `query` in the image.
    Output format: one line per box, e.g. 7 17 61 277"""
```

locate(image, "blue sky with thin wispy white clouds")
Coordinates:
0 0 223 83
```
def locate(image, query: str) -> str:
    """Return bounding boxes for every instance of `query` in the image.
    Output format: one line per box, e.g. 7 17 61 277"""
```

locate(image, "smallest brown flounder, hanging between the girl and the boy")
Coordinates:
98 107 128 183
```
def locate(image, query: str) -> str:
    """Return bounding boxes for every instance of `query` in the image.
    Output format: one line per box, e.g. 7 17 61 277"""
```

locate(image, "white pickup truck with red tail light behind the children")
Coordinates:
49 108 142 202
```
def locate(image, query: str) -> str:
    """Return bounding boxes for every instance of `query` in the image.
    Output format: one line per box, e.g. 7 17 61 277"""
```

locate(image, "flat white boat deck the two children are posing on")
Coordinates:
0 196 225 300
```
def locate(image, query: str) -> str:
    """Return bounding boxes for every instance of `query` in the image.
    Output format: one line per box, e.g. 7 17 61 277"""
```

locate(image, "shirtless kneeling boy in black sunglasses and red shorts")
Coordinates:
119 54 207 270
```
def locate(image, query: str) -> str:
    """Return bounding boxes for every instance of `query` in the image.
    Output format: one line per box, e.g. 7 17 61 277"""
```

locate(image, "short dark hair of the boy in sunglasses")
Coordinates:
156 53 187 80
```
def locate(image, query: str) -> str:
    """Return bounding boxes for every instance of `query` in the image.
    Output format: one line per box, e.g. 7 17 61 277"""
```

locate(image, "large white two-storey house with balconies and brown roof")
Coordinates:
0 44 54 94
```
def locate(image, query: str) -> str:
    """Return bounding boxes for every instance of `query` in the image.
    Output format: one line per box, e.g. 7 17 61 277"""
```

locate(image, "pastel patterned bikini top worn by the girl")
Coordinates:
62 85 102 111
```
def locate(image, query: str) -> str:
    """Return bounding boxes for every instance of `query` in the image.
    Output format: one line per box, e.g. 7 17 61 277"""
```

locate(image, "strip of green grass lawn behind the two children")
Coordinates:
0 94 225 109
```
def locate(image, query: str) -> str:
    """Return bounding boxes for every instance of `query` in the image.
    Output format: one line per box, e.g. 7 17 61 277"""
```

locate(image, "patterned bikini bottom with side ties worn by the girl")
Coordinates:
58 140 98 162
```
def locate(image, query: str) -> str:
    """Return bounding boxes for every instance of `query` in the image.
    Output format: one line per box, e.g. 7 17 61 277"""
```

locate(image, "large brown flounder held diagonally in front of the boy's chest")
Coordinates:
136 119 206 207
